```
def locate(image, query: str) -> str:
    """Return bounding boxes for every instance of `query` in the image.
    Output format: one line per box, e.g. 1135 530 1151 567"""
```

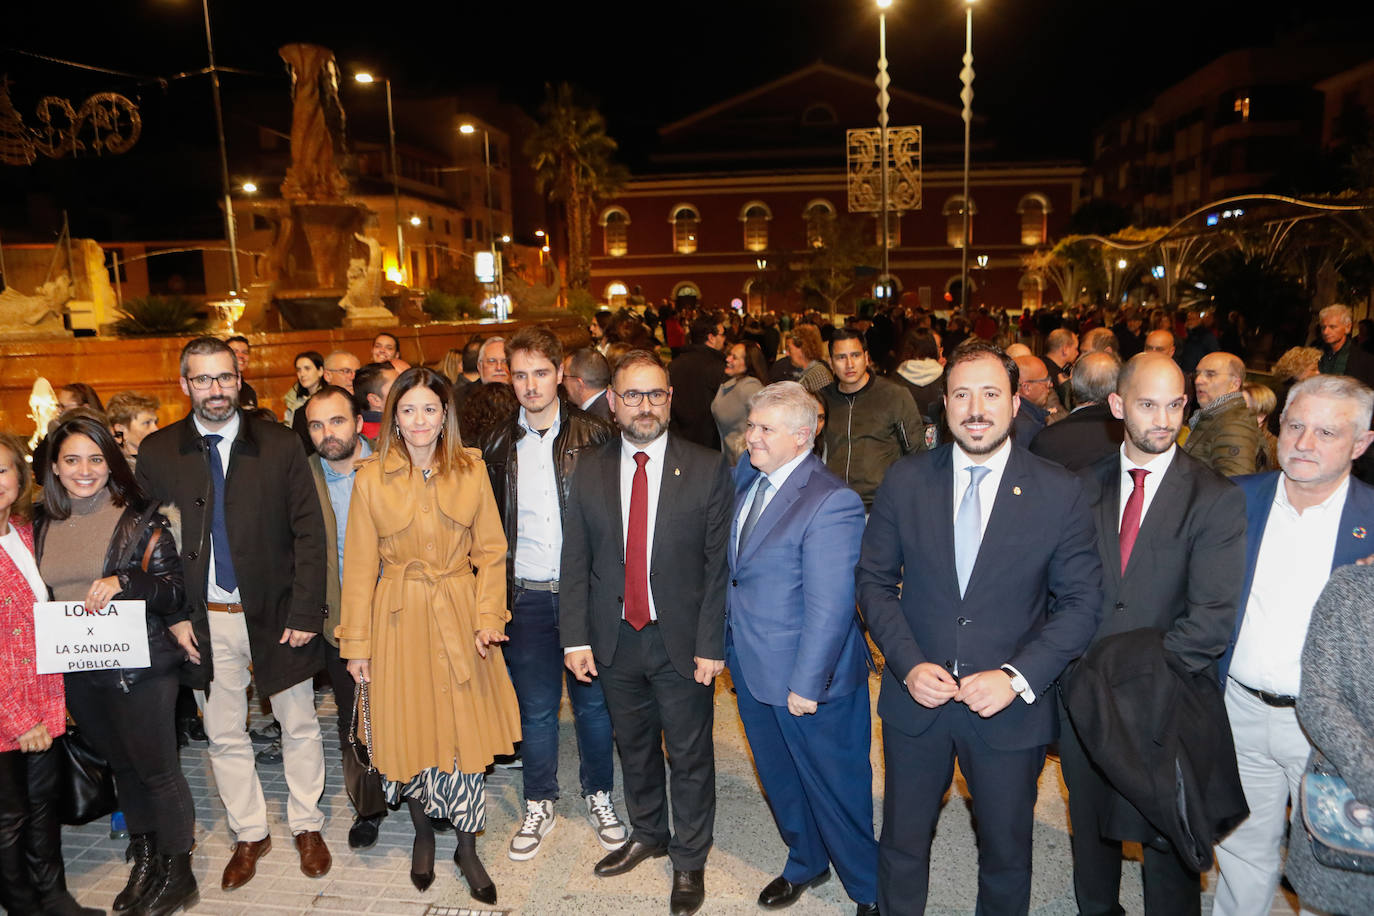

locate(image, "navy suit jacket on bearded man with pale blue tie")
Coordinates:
855 444 1102 750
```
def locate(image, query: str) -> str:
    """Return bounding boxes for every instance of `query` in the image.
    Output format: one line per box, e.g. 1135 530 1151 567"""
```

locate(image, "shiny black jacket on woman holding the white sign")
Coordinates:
33 505 187 692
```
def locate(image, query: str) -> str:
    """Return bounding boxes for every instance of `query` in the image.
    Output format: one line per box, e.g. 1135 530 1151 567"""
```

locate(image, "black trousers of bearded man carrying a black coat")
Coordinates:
1059 703 1202 916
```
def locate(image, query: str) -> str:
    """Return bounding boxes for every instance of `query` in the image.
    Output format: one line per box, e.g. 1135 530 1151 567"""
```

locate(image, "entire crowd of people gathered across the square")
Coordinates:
0 295 1374 916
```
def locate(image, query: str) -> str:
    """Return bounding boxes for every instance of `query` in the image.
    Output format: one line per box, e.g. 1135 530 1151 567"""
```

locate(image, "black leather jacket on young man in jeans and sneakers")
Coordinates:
480 397 616 596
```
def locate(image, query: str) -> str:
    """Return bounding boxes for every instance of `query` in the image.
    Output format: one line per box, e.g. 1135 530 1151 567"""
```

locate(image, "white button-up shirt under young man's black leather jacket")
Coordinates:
515 408 563 582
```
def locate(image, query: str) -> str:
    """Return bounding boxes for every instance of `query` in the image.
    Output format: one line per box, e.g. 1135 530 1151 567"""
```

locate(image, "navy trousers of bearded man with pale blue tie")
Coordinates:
878 699 1044 916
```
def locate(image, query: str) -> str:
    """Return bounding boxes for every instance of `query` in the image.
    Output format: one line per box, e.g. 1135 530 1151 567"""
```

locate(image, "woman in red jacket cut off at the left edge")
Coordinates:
0 433 104 915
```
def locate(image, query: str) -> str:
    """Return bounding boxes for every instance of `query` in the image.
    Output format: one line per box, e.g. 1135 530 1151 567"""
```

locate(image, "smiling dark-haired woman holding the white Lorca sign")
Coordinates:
34 415 199 916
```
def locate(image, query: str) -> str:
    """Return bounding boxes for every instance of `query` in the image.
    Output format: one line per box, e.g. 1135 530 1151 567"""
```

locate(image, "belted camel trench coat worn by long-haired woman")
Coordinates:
335 449 521 783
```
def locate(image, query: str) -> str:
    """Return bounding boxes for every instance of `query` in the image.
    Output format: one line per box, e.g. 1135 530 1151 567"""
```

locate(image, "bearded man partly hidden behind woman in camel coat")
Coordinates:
302 384 384 849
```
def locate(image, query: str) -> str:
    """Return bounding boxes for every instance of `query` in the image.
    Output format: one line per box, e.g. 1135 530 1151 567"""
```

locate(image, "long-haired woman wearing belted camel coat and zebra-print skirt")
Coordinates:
335 367 519 904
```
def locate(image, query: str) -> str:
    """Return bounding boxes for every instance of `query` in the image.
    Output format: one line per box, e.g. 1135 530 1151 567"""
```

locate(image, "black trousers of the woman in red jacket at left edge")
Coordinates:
0 747 66 913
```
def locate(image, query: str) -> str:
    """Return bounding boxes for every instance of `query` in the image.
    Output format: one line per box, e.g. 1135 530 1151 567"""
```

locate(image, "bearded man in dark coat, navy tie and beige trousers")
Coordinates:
136 338 331 890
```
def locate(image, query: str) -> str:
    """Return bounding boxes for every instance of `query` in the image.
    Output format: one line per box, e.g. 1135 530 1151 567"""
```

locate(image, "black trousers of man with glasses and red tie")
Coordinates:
598 622 716 871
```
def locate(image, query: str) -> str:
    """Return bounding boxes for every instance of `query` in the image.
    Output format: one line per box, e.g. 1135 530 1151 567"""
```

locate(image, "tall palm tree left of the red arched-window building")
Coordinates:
525 82 629 290
